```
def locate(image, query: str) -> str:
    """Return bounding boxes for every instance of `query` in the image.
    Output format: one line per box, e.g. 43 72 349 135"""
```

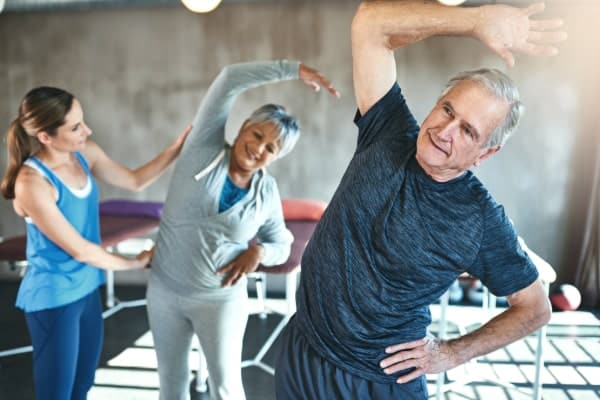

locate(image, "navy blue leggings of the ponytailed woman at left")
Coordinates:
25 290 104 400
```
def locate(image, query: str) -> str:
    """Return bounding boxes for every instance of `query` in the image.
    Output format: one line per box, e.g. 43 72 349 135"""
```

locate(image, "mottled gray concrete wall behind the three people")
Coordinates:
0 0 600 288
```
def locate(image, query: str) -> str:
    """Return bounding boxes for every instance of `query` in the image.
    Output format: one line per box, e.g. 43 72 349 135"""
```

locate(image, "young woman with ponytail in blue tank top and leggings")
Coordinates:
0 87 189 400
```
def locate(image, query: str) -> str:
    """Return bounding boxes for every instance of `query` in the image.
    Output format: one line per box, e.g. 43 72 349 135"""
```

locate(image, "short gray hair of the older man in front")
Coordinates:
438 68 525 147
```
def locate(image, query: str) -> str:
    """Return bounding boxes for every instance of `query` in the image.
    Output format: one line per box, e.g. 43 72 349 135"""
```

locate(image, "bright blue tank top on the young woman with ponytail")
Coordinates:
16 153 104 312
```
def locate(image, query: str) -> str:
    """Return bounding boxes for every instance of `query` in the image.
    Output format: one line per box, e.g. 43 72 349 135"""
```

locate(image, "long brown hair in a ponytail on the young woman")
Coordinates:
0 86 73 200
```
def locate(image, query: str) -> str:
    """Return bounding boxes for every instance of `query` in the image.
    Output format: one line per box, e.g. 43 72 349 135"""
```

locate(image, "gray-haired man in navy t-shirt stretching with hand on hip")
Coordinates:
276 0 566 400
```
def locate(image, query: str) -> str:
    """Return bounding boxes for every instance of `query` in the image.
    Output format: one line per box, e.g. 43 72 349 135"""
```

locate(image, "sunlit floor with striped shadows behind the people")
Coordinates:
0 282 600 400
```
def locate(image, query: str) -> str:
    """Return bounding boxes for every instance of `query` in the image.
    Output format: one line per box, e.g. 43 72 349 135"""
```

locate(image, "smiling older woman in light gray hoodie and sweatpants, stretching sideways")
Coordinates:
147 60 339 400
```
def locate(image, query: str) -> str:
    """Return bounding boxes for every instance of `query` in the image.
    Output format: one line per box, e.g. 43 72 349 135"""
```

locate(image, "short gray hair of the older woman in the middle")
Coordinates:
248 104 300 158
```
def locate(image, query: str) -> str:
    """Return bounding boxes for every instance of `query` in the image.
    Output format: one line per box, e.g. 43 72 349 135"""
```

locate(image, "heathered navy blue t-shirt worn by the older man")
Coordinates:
295 84 538 383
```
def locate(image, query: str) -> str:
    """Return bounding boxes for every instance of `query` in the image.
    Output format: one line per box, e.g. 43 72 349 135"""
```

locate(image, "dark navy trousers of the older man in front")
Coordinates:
275 318 427 400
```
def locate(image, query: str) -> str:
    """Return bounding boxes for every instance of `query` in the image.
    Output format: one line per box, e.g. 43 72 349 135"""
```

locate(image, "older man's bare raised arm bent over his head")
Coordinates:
352 0 566 114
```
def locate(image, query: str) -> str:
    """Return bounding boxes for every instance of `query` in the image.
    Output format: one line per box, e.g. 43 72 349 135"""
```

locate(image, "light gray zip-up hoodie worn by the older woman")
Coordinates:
152 60 299 298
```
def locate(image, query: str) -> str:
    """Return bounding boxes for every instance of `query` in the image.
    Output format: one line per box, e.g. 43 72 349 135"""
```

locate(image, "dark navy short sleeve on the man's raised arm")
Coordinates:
354 82 419 152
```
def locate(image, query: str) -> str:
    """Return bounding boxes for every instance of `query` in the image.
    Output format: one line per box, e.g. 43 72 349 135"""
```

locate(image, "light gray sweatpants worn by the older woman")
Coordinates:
146 277 248 400
